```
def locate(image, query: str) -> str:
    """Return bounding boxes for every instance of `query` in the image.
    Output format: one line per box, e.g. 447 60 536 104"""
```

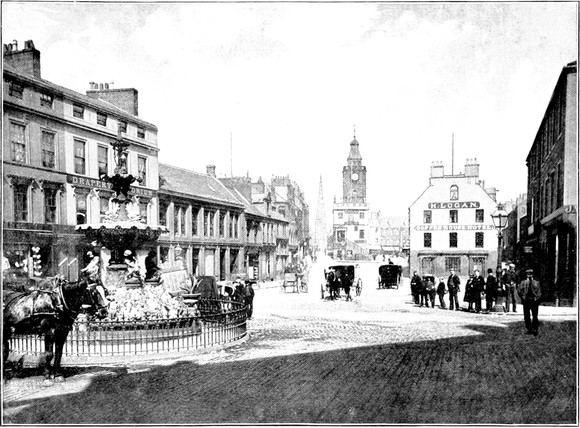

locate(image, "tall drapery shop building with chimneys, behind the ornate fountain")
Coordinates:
2 40 158 280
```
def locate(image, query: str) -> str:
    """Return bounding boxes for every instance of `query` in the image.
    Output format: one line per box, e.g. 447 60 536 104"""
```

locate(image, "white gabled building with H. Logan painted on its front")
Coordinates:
409 159 497 276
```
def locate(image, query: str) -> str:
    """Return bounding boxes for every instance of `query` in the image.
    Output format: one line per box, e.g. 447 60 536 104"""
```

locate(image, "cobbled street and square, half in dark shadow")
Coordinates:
3 267 577 424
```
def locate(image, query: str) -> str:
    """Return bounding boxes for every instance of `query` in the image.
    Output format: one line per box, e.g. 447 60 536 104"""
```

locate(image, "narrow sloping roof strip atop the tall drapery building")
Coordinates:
3 62 157 131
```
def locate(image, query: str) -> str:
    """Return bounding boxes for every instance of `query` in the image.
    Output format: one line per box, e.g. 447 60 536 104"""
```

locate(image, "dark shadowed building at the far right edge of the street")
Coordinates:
526 61 578 305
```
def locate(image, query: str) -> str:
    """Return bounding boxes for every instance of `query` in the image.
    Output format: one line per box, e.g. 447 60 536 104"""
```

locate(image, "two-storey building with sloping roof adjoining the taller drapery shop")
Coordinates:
159 164 245 280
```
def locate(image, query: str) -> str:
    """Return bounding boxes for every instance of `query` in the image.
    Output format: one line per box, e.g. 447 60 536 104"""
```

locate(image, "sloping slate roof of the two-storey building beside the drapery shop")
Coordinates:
159 163 243 208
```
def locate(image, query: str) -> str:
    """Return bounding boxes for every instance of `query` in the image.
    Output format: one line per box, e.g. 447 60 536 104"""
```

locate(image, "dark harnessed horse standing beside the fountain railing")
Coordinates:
3 277 104 379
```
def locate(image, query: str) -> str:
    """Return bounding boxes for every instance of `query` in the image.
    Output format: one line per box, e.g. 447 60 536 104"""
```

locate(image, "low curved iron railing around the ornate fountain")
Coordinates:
10 299 247 365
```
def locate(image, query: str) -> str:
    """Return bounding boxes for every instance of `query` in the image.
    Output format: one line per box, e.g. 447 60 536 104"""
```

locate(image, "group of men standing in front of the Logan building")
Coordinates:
411 263 542 336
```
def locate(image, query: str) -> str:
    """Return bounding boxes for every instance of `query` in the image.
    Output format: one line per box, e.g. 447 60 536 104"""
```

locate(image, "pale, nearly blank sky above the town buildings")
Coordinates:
2 2 578 226
